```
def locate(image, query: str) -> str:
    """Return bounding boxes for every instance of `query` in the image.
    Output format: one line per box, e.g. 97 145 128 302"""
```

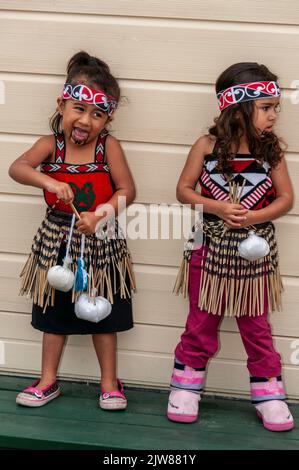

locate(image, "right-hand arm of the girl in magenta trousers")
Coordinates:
242 156 294 227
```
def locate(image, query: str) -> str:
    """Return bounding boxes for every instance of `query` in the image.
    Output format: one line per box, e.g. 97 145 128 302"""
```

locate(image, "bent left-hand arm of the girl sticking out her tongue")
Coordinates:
8 135 74 203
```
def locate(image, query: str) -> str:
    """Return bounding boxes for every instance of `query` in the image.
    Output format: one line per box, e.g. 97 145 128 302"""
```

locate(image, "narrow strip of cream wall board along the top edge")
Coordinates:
0 0 299 24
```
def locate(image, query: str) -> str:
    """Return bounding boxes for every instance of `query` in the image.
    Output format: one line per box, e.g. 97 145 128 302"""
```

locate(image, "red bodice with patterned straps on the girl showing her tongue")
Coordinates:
41 131 114 213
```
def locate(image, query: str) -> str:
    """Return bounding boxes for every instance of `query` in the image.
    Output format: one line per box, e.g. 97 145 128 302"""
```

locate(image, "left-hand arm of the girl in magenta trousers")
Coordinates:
177 135 247 228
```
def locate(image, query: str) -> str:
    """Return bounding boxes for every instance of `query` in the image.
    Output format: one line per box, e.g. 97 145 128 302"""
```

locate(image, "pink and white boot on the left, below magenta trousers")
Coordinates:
167 390 200 423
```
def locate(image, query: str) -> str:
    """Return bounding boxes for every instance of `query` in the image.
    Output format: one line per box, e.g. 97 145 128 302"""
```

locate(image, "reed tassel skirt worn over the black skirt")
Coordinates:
20 209 136 311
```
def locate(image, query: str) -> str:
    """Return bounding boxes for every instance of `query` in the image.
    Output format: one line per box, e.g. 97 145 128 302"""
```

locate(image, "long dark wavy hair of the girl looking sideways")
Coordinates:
209 62 283 175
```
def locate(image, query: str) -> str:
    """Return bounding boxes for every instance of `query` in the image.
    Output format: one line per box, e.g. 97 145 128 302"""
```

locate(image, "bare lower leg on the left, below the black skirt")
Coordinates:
38 333 66 388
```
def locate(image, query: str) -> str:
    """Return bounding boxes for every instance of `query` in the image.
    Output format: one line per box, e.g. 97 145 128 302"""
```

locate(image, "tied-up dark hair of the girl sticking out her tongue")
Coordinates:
50 51 120 134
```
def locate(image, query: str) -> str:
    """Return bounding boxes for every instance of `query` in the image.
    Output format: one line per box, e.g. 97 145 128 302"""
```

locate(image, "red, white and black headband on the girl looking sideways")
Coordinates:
217 82 280 111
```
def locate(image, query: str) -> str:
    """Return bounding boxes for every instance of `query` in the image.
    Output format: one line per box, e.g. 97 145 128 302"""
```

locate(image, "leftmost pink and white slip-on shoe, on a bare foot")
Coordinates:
16 380 61 407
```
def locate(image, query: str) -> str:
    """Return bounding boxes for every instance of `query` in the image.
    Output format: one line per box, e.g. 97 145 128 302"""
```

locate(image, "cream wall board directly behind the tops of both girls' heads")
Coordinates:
0 10 299 88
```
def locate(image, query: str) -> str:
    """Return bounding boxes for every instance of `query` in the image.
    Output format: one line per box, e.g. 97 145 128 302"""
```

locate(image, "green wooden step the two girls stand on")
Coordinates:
0 376 299 450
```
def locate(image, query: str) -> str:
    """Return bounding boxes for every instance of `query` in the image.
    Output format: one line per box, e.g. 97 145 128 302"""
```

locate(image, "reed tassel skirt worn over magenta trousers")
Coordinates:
173 220 283 317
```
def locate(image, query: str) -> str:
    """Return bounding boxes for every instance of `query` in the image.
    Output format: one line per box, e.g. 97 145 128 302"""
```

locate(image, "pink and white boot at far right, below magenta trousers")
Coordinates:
255 400 295 431
